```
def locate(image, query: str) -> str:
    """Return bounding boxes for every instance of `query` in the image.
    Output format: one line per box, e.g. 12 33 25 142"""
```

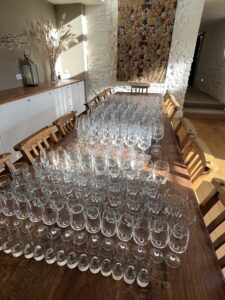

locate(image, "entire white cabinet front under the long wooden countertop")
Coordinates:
0 82 85 161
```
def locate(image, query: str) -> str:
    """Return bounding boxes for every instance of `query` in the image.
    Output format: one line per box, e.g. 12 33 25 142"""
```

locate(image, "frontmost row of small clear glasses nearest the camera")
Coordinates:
0 216 152 287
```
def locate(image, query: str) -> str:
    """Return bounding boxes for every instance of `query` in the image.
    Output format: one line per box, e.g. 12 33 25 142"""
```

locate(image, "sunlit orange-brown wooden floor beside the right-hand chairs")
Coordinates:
185 118 225 275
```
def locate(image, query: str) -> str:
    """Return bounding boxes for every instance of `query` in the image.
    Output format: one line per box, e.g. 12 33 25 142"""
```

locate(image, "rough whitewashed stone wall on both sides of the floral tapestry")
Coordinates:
85 0 205 115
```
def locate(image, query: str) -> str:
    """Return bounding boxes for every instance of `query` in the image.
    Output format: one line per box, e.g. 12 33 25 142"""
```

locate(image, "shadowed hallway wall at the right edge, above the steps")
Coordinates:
194 21 225 102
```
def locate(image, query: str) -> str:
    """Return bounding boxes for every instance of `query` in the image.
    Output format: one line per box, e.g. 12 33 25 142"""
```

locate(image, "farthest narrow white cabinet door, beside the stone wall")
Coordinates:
71 81 85 115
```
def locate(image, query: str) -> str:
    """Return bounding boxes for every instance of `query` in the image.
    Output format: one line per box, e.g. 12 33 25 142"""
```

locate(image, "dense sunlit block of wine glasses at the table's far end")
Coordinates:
76 95 163 151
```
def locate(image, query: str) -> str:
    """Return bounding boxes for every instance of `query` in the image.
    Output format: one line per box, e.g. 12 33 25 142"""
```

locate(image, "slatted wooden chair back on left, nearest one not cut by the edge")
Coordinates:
14 125 58 164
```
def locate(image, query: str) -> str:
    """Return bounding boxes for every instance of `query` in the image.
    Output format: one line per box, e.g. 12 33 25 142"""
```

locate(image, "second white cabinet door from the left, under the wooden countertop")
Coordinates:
26 90 58 132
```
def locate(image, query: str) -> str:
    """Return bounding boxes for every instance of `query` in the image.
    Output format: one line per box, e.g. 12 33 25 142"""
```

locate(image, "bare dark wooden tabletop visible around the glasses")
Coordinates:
0 92 225 300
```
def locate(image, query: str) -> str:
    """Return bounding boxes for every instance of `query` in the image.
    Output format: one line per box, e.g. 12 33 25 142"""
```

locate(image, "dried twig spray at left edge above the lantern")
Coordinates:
0 34 29 50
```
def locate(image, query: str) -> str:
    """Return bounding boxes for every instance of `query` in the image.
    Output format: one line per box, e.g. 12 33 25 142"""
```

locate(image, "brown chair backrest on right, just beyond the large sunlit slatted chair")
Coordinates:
174 118 197 152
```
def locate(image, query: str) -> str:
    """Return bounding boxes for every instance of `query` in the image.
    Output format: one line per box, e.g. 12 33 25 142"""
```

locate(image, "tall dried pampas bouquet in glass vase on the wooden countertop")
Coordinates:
32 14 78 82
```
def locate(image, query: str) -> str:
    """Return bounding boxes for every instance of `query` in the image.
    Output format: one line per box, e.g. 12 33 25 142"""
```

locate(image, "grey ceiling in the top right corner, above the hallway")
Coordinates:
202 0 225 25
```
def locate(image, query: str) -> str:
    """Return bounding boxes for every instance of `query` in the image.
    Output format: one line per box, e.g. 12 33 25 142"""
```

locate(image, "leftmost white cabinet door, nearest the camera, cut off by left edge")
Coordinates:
0 99 33 160
